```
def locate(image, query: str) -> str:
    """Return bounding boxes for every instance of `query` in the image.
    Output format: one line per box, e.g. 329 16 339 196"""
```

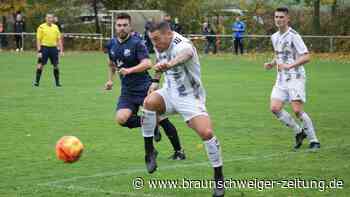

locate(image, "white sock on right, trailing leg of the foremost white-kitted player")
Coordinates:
204 136 222 168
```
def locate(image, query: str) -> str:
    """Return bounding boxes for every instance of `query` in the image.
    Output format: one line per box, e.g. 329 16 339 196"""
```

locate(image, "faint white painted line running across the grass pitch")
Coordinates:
38 144 350 186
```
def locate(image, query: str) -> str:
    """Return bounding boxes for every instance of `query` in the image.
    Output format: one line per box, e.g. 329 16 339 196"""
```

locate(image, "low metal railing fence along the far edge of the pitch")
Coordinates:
0 33 350 53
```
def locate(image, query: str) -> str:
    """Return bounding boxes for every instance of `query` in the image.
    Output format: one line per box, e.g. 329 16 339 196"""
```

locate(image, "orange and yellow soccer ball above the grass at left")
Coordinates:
56 136 84 163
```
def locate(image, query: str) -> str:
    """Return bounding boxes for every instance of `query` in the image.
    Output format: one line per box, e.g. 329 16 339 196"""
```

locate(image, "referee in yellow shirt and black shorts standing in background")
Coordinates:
34 14 63 87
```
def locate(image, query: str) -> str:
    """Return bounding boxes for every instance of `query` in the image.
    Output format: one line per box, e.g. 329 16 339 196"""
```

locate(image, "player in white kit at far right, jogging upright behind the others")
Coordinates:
264 7 320 150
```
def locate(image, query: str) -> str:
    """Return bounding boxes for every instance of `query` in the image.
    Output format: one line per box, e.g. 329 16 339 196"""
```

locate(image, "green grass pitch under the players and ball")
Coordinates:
0 52 350 197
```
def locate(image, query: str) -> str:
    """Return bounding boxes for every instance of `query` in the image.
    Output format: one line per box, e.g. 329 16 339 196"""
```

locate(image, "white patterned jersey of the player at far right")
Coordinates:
271 27 309 81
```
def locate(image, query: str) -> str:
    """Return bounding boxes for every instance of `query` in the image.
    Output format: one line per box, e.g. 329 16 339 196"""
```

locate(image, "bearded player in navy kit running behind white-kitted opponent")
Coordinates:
105 13 185 166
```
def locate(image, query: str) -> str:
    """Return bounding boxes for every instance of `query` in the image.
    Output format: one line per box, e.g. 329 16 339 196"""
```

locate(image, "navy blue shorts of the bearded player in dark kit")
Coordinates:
116 95 145 114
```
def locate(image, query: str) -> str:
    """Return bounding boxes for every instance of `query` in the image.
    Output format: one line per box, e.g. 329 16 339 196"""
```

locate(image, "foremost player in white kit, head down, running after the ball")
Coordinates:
142 21 224 196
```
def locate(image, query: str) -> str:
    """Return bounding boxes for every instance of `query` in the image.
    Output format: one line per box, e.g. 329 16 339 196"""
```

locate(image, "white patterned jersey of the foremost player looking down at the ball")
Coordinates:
155 31 205 99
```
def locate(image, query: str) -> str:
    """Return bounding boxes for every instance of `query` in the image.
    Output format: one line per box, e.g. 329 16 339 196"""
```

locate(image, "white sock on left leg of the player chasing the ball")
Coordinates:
141 109 157 137
